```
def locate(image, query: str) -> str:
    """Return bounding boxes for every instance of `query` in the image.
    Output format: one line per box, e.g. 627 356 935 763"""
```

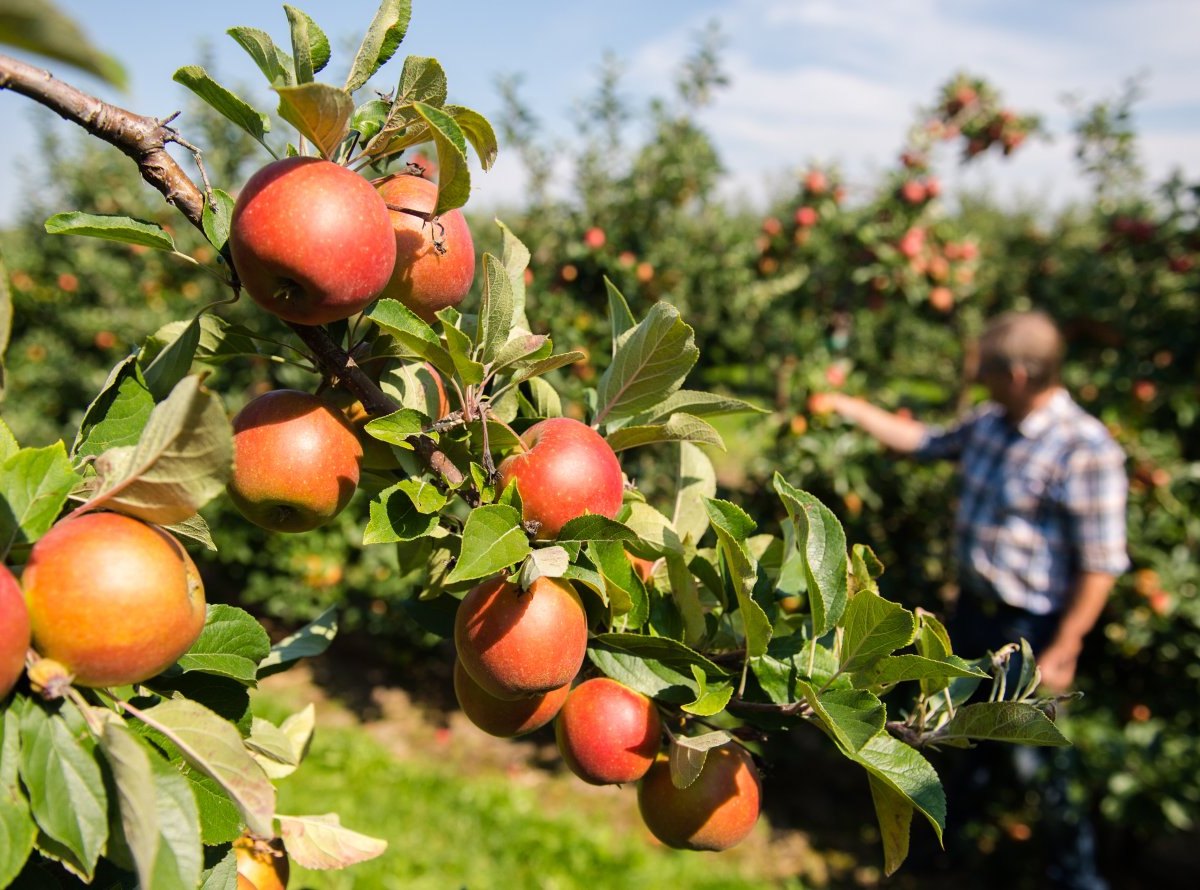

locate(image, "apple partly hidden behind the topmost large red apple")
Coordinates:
379 174 475 323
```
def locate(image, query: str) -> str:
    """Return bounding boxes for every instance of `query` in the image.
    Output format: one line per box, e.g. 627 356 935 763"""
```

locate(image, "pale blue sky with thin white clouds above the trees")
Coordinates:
0 0 1200 222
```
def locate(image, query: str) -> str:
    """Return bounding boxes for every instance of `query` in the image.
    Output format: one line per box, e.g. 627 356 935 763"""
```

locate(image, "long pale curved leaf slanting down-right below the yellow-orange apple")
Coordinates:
136 698 275 837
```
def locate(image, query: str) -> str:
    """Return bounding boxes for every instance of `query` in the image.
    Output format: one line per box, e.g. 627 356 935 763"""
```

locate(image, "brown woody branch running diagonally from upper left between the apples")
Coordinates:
0 54 464 488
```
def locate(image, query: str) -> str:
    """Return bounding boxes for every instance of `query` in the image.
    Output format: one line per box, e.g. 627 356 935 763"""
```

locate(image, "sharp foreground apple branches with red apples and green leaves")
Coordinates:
0 0 1066 889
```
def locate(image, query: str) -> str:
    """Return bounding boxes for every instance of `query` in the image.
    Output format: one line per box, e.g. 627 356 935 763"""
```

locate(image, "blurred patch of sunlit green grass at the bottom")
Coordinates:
256 693 796 890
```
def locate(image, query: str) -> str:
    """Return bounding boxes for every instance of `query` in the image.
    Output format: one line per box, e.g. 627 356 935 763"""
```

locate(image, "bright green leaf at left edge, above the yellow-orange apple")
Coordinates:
0 441 79 558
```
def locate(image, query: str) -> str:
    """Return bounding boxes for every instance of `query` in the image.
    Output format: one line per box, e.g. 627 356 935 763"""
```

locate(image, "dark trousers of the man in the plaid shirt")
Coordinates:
937 591 1108 890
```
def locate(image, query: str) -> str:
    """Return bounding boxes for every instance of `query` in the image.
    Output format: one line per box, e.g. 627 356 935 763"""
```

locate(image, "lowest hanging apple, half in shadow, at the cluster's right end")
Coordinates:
637 742 762 850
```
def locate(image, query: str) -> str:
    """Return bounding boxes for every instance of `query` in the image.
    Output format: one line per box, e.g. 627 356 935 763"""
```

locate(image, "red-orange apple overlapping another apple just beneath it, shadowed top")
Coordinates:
454 577 588 699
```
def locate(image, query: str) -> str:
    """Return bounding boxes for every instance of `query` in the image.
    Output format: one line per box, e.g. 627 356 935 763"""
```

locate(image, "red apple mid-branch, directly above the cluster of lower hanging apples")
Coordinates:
497 417 625 540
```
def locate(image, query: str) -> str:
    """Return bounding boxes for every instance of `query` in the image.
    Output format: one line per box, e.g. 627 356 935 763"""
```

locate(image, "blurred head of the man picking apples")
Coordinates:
977 312 1063 420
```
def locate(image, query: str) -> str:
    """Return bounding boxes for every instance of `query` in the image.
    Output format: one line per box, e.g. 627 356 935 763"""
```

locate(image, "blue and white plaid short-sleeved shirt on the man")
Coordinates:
914 390 1129 614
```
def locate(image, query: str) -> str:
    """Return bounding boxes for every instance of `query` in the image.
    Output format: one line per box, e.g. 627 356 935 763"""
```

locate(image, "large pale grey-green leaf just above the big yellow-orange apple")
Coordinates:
88 377 233 525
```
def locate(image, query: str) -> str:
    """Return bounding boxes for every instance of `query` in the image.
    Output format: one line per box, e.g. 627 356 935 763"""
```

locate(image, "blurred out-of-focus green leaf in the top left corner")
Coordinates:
0 0 128 90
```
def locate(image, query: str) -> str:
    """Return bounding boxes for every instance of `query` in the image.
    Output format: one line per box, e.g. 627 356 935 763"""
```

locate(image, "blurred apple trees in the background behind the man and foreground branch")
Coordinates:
0 1 1200 886
